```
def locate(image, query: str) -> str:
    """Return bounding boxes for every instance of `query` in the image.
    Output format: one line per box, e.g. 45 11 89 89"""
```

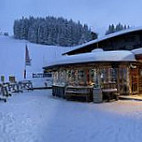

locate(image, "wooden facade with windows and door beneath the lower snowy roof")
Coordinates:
44 62 142 101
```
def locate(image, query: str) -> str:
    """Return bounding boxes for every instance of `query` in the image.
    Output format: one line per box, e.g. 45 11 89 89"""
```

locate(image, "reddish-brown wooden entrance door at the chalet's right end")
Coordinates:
131 68 139 94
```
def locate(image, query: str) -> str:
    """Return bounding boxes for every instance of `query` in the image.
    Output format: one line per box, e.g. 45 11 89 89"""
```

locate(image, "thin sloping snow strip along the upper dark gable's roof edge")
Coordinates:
64 27 142 54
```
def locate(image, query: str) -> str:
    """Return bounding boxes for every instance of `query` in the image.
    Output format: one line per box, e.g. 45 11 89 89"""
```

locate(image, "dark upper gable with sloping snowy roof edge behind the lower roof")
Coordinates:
63 27 142 55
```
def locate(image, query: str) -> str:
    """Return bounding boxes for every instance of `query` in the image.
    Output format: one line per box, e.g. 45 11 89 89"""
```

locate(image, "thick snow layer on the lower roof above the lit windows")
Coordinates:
47 50 136 68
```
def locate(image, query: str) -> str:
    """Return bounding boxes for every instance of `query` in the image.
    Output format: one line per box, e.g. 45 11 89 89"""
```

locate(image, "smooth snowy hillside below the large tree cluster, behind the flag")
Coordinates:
0 36 69 80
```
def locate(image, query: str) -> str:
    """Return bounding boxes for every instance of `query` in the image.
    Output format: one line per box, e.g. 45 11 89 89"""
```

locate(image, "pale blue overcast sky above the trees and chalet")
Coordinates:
0 0 142 34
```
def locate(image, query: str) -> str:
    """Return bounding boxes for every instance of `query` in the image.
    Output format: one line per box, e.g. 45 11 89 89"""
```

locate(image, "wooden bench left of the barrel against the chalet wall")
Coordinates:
65 86 93 102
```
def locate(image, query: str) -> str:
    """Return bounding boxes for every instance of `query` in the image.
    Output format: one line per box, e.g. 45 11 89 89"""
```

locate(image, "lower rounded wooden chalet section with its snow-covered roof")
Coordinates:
44 50 142 101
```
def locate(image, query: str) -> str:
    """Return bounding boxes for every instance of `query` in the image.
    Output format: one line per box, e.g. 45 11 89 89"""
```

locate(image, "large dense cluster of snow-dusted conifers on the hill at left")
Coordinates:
13 16 97 46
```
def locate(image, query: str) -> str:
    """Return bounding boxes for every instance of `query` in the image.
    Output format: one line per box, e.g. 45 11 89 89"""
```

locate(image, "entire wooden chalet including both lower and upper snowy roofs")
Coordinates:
44 29 142 102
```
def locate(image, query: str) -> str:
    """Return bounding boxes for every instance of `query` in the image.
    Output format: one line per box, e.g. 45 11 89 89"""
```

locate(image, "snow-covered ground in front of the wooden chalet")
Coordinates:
0 90 142 142
